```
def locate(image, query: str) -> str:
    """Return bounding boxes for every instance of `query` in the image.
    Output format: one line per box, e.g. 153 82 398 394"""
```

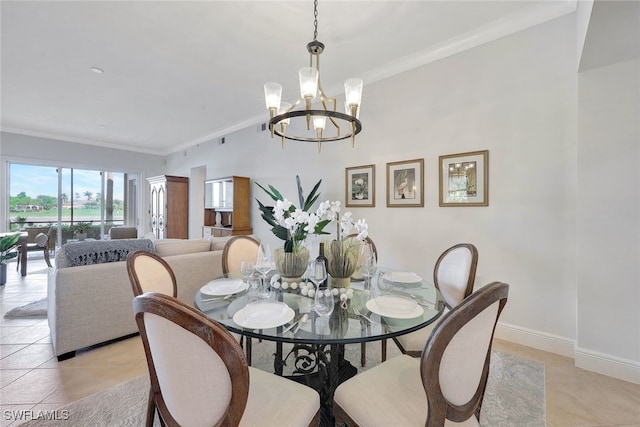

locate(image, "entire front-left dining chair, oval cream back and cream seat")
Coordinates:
133 293 320 426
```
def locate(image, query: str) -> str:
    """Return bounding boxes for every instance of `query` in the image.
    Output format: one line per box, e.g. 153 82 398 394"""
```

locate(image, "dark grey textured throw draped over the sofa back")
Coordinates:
56 239 154 268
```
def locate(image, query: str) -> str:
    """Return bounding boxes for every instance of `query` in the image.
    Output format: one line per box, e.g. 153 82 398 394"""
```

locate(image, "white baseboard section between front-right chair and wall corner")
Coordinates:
495 322 575 358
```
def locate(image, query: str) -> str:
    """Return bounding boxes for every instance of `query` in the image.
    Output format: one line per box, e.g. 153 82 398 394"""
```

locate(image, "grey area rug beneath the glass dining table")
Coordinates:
16 341 546 427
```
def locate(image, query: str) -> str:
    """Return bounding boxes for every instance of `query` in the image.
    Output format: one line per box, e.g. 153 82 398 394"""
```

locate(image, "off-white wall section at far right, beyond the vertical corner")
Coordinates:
576 60 640 382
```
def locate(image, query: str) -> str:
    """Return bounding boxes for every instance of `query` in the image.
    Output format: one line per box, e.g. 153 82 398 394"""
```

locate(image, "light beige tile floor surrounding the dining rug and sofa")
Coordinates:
0 254 640 427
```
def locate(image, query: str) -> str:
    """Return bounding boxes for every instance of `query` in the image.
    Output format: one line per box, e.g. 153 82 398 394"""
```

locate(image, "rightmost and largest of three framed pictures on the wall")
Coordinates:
439 150 489 207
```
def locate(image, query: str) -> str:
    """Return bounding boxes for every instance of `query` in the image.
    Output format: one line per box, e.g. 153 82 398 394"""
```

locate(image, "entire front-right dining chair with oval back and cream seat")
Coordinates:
333 282 509 427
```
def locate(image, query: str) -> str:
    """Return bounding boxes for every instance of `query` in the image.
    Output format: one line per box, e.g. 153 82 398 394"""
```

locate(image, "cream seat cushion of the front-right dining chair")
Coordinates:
334 354 480 427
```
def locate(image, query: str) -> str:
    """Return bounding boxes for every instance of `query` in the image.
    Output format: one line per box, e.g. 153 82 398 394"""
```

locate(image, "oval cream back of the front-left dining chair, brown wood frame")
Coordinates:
133 293 249 426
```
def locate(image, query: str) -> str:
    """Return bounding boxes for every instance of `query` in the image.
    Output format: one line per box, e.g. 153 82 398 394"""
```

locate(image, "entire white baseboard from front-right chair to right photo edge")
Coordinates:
495 322 640 384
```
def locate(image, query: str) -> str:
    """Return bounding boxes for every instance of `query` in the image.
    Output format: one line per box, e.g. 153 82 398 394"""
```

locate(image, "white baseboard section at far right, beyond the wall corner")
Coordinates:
575 347 640 384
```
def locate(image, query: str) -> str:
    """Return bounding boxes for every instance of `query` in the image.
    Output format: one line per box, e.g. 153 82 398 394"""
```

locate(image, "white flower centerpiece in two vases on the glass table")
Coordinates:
256 176 368 286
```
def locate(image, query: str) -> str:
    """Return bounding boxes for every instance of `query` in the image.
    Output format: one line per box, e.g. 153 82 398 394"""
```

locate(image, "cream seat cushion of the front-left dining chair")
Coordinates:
240 367 320 427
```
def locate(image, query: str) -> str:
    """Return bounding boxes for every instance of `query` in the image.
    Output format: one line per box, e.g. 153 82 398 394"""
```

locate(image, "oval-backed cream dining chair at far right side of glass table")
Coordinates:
382 243 478 361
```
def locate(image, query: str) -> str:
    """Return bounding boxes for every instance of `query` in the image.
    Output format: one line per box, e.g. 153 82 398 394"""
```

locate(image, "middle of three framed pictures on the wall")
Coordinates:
387 159 424 208
